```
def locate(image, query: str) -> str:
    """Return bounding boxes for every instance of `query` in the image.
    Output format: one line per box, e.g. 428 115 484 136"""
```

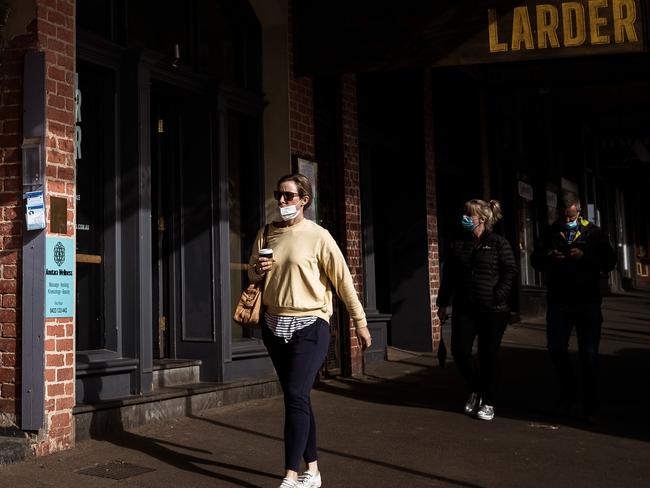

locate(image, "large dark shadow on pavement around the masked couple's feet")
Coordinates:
317 292 650 442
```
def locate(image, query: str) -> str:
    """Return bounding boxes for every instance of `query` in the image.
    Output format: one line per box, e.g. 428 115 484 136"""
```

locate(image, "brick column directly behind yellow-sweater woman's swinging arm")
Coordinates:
340 75 363 375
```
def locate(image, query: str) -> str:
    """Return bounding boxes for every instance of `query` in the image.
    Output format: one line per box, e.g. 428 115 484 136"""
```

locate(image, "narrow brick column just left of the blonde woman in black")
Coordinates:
422 69 440 351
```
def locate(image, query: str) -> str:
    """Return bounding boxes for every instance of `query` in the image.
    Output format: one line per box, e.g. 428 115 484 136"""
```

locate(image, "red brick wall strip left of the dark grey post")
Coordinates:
0 3 37 421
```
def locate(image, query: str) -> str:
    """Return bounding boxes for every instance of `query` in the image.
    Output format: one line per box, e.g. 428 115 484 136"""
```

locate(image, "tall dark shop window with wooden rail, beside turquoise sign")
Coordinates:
76 62 117 351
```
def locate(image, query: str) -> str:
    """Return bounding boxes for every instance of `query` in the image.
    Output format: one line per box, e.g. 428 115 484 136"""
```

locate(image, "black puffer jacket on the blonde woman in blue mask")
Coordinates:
436 230 517 312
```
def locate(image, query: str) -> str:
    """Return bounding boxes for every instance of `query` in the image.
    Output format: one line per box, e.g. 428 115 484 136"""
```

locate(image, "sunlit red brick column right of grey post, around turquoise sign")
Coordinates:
35 0 76 455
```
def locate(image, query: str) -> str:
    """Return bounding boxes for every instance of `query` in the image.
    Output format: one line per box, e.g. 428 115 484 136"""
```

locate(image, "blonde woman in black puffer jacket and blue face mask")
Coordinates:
436 200 517 420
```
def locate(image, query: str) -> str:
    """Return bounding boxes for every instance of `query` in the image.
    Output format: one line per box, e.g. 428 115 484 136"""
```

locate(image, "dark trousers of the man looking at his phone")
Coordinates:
546 302 603 414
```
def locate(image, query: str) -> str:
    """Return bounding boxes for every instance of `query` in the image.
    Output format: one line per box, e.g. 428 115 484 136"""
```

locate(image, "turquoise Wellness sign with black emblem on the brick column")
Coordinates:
45 236 75 317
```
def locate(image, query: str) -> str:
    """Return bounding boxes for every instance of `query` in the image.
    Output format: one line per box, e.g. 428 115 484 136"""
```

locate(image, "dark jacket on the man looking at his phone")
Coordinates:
530 219 616 303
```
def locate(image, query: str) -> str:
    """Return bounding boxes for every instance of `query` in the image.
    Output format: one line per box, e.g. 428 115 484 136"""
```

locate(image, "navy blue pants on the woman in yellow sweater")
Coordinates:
262 319 330 471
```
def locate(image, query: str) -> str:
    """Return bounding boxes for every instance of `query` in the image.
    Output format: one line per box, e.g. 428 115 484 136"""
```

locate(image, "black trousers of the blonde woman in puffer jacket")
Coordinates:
451 308 510 406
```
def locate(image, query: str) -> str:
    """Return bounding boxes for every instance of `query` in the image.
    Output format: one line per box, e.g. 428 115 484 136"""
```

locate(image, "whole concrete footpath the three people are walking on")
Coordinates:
0 293 650 488
